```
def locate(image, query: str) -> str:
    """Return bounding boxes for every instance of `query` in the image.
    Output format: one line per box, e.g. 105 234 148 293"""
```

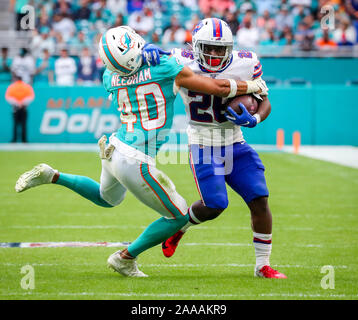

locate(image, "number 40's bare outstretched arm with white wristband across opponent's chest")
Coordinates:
175 66 261 98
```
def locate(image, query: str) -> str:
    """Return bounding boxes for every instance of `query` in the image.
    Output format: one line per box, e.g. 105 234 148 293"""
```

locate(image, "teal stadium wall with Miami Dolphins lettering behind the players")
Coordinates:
0 84 358 146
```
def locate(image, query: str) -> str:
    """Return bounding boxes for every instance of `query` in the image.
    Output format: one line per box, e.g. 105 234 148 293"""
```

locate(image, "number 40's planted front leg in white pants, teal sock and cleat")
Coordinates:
108 150 188 276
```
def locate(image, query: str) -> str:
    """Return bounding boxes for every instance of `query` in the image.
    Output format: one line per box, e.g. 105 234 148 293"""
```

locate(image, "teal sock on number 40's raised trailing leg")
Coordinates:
55 172 112 208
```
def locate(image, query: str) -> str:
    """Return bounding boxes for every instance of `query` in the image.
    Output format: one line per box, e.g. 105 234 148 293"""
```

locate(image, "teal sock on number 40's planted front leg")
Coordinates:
128 214 189 257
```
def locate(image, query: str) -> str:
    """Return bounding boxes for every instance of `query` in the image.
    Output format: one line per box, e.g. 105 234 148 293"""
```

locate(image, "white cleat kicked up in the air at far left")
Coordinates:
15 163 57 192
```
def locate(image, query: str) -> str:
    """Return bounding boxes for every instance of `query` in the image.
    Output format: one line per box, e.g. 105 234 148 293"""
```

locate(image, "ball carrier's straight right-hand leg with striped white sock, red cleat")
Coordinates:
226 143 285 278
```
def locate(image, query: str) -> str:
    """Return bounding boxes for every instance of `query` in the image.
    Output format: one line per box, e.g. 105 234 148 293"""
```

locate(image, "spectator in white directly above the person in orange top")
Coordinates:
11 48 35 83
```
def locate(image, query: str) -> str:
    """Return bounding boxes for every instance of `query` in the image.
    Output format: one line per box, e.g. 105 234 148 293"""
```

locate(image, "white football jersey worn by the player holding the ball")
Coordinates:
172 49 262 146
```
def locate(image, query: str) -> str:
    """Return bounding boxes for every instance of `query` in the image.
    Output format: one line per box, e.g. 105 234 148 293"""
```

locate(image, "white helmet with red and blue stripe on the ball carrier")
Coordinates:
192 18 234 72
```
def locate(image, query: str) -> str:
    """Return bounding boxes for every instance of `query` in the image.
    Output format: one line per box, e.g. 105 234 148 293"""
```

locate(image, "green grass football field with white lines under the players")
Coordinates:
0 152 358 300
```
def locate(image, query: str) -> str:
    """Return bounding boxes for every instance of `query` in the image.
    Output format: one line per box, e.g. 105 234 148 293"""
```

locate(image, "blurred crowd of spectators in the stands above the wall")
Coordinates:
0 0 358 86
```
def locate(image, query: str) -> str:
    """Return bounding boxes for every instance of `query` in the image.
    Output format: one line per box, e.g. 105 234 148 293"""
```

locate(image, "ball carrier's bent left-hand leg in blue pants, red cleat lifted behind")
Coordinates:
162 145 228 258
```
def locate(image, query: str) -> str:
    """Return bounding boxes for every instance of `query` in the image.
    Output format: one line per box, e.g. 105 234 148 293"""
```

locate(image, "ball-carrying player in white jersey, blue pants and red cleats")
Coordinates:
144 18 286 278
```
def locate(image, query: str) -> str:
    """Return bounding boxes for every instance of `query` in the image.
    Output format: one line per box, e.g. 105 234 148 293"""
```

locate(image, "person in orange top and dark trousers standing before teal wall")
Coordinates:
5 76 35 143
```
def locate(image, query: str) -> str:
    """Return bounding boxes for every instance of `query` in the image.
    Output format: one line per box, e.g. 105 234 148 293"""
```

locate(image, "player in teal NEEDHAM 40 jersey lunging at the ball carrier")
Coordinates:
15 26 265 277
